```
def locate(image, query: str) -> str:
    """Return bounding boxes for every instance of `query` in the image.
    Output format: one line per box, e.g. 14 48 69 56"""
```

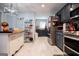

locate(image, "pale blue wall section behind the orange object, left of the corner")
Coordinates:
1 13 17 28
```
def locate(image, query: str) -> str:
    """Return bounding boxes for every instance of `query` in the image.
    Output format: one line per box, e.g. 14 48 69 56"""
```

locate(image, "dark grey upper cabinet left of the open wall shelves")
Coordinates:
57 4 70 22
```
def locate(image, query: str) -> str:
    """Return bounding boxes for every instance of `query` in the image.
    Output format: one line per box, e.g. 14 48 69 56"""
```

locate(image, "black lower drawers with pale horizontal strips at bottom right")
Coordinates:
64 37 79 56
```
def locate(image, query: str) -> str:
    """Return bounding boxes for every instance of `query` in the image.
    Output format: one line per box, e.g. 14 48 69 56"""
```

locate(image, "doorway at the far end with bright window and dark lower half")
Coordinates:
36 19 48 37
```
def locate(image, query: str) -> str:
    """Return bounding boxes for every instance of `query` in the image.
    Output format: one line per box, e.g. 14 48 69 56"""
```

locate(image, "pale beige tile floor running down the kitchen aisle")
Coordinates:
15 37 63 56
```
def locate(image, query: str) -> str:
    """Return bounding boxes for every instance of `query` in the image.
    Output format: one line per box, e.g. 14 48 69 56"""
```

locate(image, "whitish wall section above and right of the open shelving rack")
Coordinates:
17 12 35 38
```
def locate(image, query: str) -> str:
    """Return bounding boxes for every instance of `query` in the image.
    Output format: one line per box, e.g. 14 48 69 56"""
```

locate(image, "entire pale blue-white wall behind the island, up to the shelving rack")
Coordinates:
1 13 34 29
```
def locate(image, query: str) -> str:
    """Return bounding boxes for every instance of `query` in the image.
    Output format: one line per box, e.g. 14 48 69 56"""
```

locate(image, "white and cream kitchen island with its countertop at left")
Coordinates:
0 31 24 56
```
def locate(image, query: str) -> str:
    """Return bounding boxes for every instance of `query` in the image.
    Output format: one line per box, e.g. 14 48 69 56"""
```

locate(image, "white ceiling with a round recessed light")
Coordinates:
13 3 65 15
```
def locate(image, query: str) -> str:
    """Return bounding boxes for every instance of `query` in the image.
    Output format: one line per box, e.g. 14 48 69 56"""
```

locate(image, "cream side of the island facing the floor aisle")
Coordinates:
9 33 24 55
